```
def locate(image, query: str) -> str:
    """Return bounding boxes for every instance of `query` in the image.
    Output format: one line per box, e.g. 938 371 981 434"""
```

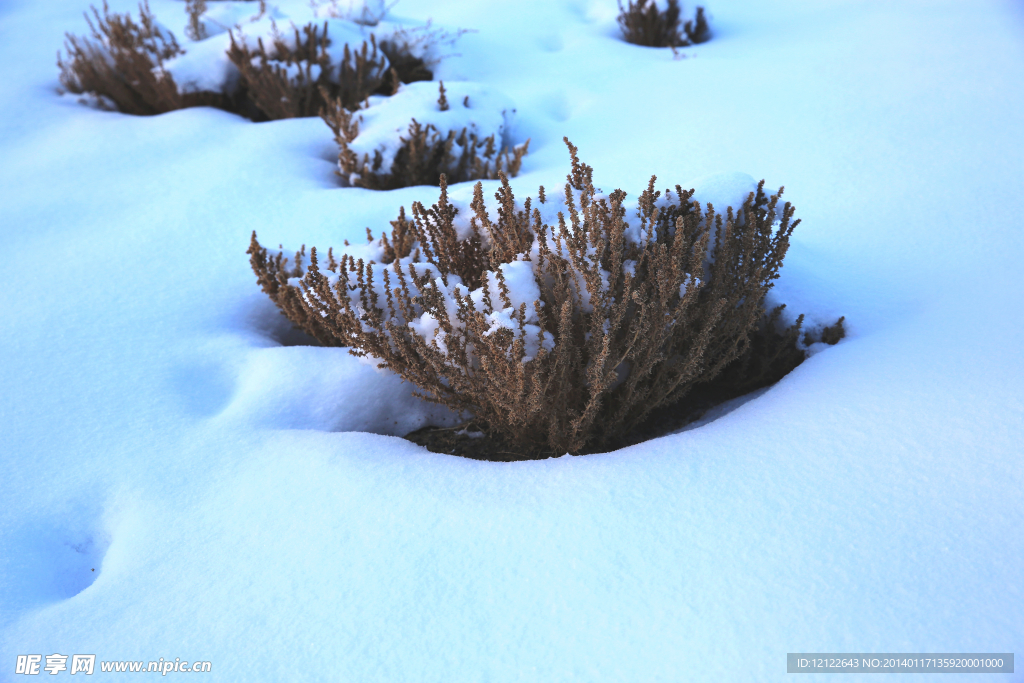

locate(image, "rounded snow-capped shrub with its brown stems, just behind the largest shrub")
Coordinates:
322 83 529 189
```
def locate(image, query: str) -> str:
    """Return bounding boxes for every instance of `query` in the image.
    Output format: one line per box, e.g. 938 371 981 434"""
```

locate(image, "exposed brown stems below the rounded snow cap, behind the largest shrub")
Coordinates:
321 83 529 189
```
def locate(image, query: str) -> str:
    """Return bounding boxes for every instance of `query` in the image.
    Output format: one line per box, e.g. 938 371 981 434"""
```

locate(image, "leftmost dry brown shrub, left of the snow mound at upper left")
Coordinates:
57 0 188 116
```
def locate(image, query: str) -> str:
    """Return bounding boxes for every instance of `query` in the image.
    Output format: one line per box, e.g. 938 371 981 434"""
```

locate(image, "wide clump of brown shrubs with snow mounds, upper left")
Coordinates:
57 0 448 121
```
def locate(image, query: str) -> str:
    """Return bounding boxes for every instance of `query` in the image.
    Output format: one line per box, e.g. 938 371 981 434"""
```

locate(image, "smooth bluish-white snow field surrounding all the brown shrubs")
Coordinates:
0 0 1024 682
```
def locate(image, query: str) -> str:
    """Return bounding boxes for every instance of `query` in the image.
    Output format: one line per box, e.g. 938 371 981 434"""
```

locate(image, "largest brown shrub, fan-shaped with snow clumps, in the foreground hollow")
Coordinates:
248 140 823 453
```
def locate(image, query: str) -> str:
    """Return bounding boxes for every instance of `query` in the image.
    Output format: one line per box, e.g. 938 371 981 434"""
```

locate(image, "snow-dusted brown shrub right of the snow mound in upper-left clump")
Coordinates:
227 22 388 120
